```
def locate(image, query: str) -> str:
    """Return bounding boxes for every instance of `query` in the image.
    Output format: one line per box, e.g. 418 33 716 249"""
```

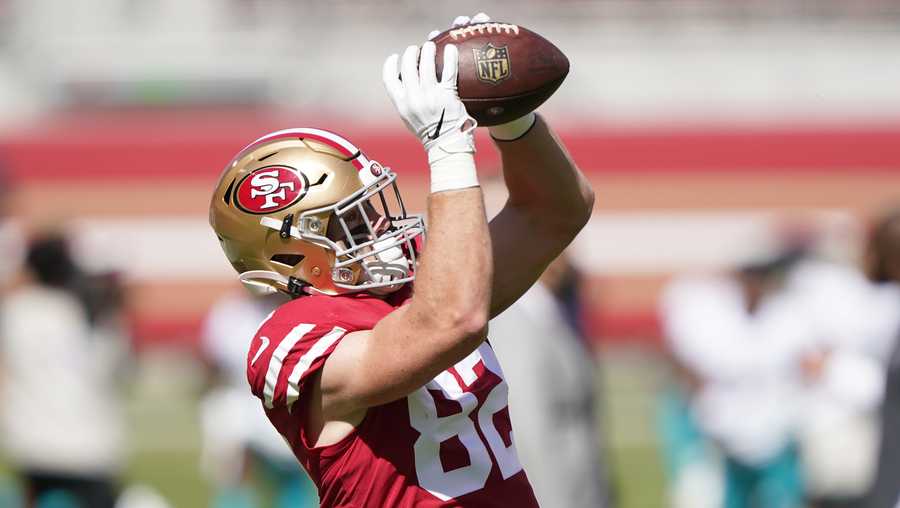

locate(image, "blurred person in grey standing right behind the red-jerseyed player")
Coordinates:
490 254 612 508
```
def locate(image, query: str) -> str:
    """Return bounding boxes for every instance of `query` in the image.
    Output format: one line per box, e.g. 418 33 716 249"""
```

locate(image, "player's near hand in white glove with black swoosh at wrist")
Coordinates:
382 41 476 162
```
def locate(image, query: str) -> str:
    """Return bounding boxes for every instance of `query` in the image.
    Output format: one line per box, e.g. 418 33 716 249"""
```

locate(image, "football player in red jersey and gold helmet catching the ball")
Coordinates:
210 15 593 507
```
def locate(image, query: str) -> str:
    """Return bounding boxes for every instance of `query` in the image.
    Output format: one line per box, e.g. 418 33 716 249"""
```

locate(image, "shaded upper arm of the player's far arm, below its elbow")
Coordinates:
489 203 569 318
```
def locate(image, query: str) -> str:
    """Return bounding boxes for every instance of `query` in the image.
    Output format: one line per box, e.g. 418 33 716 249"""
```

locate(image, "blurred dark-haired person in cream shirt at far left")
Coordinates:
0 235 128 508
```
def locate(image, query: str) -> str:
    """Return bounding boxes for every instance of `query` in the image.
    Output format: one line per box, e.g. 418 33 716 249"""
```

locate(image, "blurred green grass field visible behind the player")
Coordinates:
0 351 665 508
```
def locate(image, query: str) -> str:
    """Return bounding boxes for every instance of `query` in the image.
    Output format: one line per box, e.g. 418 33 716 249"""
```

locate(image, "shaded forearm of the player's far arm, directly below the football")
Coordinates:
495 116 594 232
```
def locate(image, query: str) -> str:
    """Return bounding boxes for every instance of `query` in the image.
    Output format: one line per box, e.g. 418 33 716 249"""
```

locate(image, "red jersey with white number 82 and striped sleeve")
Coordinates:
247 293 538 508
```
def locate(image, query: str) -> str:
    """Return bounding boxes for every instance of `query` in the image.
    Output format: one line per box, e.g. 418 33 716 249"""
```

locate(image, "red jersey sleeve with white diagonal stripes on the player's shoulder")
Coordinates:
247 315 347 409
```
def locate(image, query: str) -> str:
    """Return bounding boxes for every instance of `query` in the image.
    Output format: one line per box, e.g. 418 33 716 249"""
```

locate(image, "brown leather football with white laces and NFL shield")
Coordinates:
434 21 569 126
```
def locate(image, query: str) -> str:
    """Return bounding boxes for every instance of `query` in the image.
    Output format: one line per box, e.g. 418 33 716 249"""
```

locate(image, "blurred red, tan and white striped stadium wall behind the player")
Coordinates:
0 109 900 347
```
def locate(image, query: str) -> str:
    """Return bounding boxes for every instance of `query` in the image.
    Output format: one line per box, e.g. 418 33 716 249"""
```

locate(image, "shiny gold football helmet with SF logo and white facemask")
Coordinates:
209 128 425 296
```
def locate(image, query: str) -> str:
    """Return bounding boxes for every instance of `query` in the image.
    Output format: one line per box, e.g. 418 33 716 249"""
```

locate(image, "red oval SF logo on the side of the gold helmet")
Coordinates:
235 166 308 214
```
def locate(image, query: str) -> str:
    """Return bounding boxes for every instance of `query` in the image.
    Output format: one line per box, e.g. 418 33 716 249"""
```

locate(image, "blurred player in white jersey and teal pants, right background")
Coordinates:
660 253 809 508
